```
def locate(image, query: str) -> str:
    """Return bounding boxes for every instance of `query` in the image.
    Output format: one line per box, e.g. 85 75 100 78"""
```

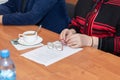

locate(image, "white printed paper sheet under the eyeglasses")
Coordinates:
21 45 82 66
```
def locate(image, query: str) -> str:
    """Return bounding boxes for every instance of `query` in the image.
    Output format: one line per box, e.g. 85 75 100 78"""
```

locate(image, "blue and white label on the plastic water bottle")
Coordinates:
0 70 16 80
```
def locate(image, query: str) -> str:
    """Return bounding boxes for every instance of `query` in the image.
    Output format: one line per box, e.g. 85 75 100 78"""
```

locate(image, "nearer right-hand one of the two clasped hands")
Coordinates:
66 34 93 48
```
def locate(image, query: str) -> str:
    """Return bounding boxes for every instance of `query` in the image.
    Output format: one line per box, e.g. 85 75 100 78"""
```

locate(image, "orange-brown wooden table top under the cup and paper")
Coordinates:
0 25 120 80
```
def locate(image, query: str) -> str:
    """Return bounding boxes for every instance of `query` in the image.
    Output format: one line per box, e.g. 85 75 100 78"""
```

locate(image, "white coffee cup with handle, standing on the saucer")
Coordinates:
18 31 38 43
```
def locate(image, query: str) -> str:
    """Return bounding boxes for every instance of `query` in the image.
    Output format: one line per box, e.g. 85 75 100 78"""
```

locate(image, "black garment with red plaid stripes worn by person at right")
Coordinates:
69 0 120 55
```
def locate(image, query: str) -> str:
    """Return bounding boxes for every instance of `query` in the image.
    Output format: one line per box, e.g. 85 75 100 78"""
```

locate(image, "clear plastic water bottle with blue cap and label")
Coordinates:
0 50 16 80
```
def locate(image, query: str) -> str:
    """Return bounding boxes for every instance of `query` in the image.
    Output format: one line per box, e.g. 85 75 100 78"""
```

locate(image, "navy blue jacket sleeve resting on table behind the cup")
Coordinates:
3 0 57 25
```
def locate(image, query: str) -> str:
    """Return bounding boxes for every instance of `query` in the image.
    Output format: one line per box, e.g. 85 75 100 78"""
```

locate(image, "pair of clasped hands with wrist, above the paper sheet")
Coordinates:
60 29 98 48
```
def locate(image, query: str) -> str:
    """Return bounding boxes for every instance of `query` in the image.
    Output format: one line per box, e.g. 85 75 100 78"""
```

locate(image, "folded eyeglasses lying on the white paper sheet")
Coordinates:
47 41 63 51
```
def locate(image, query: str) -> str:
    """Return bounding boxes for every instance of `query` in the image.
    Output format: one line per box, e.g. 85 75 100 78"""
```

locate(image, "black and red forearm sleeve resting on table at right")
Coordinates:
98 20 120 56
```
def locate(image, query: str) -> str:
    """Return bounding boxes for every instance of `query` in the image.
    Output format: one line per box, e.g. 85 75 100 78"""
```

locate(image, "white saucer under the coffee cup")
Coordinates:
18 36 43 46
